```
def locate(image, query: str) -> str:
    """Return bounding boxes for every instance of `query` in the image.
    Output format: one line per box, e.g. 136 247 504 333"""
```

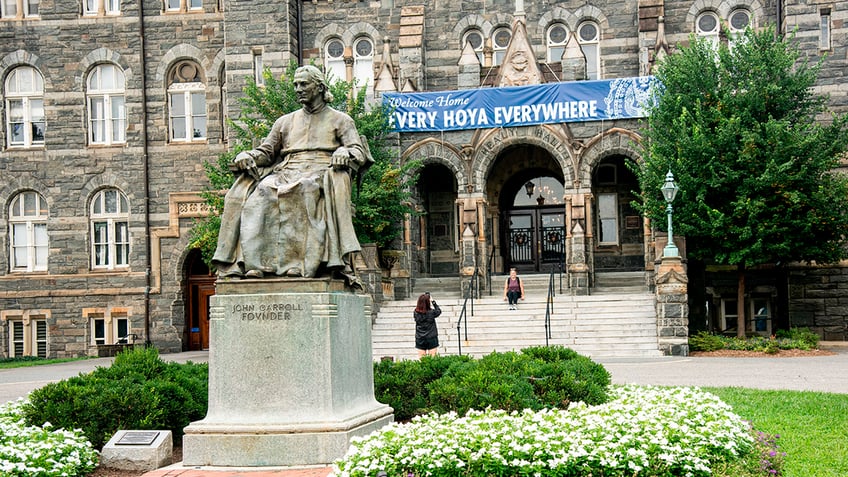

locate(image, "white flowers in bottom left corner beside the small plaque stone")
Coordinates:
0 399 98 477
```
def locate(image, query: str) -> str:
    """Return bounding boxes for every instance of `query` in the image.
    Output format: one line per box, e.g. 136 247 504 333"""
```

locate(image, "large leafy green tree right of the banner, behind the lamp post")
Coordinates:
637 27 848 337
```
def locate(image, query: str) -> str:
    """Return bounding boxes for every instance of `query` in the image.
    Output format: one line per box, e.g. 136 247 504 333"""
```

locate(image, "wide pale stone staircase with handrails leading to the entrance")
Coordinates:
372 272 661 360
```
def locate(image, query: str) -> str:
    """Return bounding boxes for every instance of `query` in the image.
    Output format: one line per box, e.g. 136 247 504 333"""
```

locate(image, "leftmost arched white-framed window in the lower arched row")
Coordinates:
9 191 48 272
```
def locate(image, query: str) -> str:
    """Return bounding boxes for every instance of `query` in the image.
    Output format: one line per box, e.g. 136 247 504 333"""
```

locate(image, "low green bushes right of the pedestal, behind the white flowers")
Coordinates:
374 346 610 421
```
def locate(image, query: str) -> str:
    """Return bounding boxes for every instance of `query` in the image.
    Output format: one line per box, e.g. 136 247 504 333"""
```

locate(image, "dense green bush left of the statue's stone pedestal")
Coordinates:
23 348 208 449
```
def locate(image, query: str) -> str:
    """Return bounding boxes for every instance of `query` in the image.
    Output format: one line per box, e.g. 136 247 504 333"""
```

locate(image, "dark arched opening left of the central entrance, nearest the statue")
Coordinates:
416 164 459 276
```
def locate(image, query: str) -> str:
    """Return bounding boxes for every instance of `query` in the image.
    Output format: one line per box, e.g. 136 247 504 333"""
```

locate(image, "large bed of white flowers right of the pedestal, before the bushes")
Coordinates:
333 386 754 477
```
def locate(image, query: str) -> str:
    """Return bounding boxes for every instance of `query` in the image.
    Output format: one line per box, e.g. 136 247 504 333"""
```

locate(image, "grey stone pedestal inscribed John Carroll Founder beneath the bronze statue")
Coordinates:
183 279 393 467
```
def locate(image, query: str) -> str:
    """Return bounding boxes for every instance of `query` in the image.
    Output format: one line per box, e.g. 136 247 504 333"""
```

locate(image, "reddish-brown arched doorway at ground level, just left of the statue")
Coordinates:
184 249 216 351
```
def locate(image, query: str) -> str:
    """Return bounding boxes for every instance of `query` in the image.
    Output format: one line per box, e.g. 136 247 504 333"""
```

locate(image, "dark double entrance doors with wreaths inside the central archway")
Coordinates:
504 206 565 272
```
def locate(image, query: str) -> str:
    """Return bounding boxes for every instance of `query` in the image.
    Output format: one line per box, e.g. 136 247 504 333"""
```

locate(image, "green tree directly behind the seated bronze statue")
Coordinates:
188 63 418 267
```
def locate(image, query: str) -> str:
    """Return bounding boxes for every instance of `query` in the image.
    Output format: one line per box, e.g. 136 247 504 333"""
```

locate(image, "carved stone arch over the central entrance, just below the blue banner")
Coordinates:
471 124 575 194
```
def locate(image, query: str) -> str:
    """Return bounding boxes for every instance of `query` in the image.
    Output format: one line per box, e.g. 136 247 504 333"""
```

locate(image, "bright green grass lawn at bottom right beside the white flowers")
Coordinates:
704 388 848 477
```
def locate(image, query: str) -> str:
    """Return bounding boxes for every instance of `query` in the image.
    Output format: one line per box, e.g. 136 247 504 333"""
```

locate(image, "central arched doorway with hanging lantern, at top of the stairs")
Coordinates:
489 145 565 273
